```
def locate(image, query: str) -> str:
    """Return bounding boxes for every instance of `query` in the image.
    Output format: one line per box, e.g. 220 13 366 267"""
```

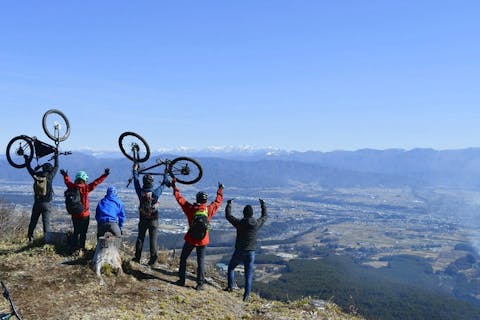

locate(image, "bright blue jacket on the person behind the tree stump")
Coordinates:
95 187 125 229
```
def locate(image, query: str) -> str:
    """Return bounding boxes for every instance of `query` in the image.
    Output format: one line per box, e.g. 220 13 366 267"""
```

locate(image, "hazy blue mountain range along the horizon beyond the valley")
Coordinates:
0 148 480 188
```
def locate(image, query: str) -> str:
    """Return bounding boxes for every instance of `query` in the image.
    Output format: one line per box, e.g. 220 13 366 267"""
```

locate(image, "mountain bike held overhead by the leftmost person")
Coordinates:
6 109 71 169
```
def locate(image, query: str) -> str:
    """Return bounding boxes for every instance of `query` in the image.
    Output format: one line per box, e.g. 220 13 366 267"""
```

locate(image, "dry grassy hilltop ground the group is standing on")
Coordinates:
0 234 361 320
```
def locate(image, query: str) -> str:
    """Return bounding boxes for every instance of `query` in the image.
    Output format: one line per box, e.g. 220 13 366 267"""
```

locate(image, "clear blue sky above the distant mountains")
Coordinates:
0 0 480 151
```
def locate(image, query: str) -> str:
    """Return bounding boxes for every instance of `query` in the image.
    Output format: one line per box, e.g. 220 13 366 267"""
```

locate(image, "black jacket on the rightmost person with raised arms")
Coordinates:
225 203 267 250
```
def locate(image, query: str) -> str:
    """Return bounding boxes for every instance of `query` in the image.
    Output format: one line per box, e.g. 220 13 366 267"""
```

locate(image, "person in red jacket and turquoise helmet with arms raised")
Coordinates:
60 168 110 250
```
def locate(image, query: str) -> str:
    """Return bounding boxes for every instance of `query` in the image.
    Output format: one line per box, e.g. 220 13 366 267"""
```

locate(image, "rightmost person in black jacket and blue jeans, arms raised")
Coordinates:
225 199 267 302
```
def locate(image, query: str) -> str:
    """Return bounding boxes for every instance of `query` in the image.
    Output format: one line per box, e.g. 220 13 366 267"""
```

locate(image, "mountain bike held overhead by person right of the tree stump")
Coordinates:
118 131 203 187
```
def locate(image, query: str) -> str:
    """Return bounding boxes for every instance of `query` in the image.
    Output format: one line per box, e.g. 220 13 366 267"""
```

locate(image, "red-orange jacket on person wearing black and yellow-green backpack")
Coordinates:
173 186 223 247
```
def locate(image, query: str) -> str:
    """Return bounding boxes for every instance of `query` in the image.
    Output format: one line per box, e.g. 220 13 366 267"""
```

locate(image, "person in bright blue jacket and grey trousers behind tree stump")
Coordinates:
95 186 125 238
